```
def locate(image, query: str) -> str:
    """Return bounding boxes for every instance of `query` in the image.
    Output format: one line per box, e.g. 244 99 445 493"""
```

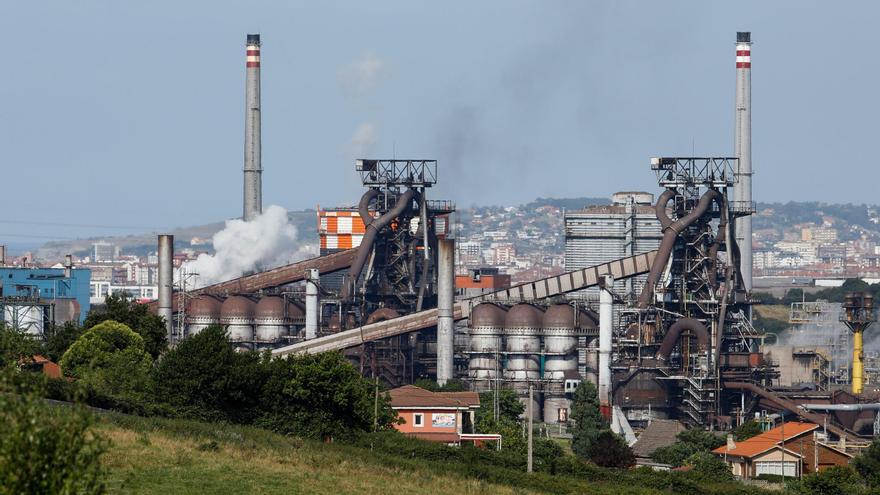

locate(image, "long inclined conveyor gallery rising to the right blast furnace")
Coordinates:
272 251 657 356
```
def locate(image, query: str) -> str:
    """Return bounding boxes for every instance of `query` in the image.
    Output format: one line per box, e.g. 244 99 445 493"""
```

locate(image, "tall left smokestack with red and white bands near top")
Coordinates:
244 34 263 221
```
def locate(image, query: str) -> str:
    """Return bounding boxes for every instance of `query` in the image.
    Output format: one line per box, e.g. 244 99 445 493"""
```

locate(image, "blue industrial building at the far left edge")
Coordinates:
0 267 92 330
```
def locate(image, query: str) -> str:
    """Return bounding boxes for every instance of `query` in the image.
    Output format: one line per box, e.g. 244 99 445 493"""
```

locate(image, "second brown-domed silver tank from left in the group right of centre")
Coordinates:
504 304 544 419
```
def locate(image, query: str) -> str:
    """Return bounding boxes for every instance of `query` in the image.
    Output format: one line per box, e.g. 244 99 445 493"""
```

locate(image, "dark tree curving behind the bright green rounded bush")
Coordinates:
83 292 168 359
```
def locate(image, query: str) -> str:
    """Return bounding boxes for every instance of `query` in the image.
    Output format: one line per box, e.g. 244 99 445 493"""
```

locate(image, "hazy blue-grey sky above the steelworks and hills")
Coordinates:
0 0 880 240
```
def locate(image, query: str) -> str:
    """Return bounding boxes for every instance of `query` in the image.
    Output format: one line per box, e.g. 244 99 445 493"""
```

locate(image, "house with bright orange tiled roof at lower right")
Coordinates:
712 421 852 478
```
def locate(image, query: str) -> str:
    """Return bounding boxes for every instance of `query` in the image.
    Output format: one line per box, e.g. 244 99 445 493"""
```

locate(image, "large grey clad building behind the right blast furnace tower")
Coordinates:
565 192 663 297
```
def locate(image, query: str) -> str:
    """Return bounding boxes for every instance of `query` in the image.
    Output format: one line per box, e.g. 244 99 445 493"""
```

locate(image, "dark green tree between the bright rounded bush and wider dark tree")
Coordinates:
151 325 265 423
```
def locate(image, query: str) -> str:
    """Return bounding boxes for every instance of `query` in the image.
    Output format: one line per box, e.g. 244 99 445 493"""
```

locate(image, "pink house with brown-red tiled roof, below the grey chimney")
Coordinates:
388 385 501 447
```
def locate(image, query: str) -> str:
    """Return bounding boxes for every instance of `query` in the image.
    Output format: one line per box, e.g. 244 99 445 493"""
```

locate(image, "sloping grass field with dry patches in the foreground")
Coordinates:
97 413 765 495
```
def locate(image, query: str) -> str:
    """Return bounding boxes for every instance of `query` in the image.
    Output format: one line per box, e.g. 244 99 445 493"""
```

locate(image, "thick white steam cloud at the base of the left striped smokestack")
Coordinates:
185 205 315 288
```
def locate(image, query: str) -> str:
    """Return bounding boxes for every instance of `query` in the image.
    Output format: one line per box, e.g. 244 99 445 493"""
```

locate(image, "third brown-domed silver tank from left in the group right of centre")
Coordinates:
543 304 577 423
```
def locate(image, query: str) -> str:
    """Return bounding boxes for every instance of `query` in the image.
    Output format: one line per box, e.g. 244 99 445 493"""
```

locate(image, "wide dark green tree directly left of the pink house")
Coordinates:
257 352 396 439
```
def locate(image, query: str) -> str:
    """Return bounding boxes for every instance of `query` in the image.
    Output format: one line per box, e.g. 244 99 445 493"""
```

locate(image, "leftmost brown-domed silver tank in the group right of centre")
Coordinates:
468 303 506 392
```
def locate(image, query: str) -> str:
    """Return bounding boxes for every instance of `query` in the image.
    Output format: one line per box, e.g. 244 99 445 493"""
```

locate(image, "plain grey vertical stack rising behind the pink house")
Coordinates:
437 239 455 387
